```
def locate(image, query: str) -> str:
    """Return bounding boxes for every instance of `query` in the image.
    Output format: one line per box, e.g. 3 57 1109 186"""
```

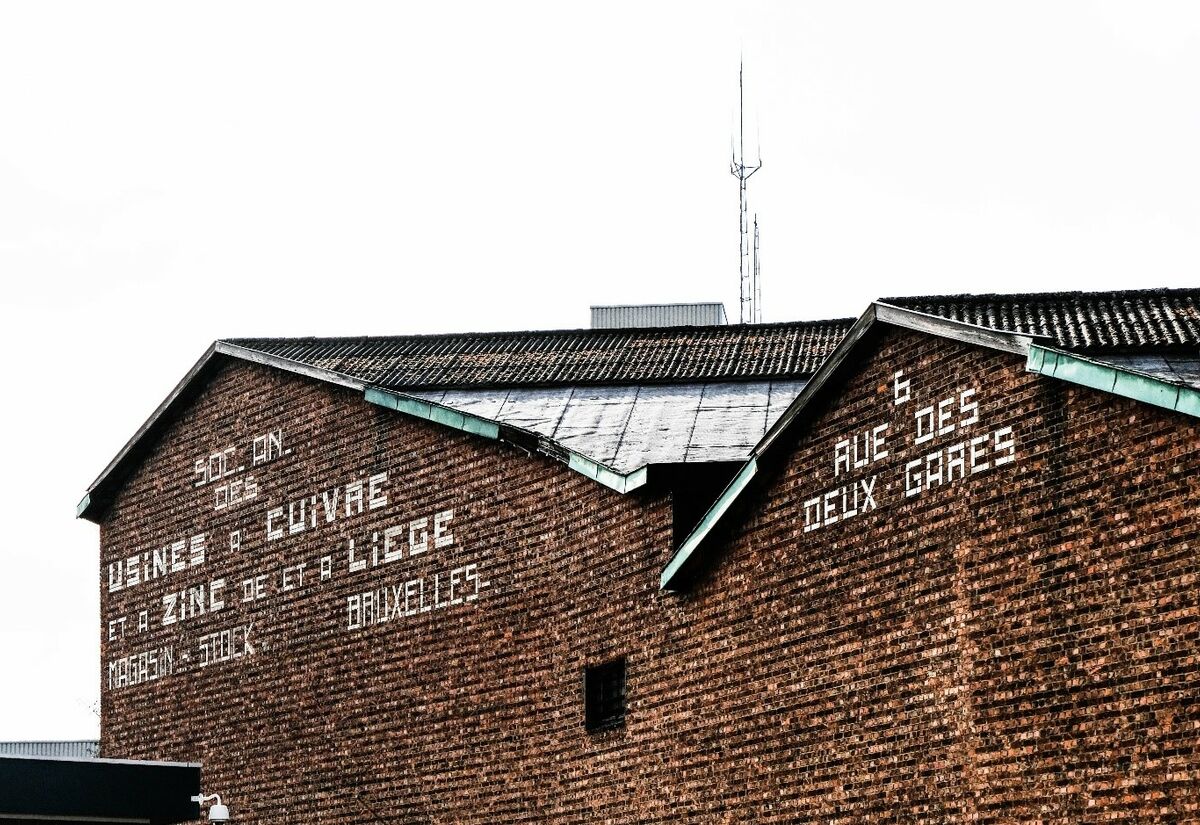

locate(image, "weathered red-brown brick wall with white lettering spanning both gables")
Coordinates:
101 331 1200 823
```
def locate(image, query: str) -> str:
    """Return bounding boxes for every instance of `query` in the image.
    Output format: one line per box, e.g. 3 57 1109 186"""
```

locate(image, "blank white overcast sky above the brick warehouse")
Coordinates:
0 0 1200 740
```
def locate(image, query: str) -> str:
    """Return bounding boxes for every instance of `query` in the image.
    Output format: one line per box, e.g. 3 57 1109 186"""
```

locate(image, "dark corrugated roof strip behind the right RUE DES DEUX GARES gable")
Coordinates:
882 289 1200 351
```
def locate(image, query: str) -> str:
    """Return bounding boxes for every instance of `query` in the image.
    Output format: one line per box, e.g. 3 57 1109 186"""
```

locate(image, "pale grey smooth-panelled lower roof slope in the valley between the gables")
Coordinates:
410 380 804 472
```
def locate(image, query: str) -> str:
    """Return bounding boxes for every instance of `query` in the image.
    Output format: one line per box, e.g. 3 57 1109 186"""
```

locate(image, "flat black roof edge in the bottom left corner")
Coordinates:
0 755 200 825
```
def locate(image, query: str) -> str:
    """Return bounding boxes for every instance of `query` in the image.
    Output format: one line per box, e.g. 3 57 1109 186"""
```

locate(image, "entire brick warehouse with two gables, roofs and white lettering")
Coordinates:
79 290 1200 823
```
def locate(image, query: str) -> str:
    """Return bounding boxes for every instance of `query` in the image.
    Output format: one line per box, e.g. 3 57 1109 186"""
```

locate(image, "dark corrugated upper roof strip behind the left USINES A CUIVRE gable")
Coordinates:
229 319 853 390
